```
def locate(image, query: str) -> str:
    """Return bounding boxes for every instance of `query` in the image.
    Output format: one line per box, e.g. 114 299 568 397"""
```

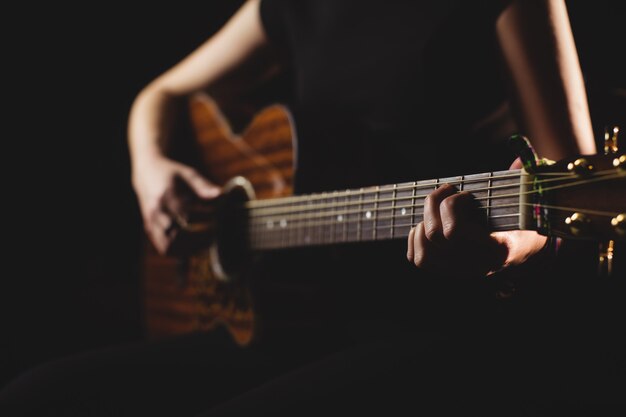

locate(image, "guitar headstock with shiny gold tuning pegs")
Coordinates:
522 127 626 275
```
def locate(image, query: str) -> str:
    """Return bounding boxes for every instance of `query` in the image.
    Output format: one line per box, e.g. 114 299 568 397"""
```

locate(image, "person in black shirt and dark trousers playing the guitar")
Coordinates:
5 0 624 415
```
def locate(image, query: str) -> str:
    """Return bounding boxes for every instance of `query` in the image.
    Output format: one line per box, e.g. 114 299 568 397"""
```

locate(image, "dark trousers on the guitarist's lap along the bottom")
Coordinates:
0 318 626 416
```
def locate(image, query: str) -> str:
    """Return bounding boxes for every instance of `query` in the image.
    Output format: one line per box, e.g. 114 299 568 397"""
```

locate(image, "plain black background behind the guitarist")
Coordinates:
0 0 626 386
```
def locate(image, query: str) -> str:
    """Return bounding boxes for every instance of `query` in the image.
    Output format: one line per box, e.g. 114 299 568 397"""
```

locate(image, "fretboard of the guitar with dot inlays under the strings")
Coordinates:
247 170 522 250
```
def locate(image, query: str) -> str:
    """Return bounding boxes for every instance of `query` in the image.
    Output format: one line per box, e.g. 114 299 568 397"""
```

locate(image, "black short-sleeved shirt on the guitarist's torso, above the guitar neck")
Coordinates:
261 0 512 192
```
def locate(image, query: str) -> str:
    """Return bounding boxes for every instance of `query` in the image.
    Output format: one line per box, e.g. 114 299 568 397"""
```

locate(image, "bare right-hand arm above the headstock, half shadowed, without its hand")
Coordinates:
496 0 595 160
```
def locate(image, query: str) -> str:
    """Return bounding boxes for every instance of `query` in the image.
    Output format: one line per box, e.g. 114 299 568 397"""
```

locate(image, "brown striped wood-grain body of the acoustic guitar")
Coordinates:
144 95 294 345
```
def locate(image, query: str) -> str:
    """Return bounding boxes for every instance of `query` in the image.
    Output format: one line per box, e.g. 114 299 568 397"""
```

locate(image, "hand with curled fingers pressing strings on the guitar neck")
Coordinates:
407 160 547 276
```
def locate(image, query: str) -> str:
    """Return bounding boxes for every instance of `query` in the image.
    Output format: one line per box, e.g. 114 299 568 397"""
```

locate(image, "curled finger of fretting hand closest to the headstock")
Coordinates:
439 192 489 242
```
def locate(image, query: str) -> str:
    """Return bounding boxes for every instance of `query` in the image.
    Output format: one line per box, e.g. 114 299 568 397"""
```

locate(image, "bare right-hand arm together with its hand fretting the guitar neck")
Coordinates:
407 0 595 275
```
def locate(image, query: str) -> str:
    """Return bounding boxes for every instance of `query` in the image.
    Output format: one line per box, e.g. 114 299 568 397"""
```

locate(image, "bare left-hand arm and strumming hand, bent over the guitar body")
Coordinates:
128 0 267 253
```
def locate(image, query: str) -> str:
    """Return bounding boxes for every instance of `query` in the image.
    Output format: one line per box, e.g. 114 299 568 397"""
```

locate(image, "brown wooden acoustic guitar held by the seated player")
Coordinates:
144 95 626 345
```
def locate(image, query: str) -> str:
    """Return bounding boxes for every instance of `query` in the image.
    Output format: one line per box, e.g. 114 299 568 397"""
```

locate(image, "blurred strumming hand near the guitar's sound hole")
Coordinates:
132 157 221 254
